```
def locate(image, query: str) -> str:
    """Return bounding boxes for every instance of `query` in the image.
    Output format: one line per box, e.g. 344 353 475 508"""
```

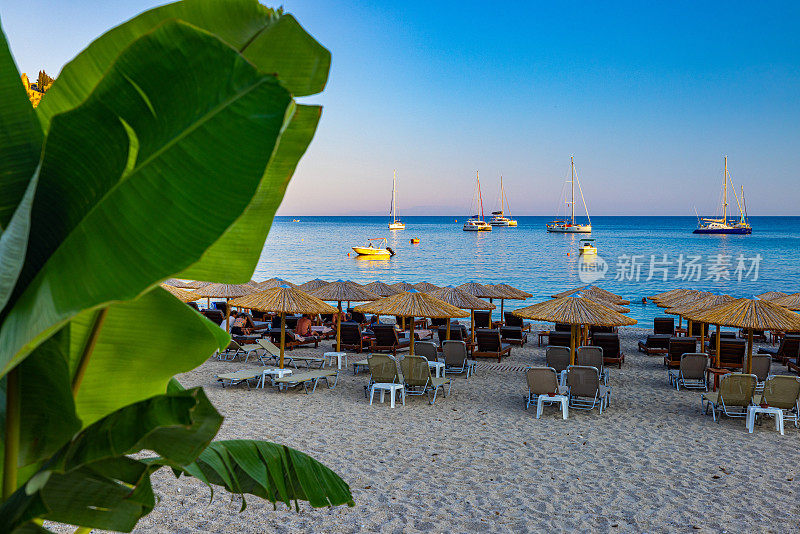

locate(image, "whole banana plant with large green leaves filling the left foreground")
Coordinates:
0 0 353 532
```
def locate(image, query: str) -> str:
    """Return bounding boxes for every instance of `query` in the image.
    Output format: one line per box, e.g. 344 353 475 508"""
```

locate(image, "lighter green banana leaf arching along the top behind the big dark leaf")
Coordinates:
37 0 330 131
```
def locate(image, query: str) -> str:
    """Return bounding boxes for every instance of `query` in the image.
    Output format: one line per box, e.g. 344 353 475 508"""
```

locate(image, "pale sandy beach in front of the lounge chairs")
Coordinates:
128 327 800 533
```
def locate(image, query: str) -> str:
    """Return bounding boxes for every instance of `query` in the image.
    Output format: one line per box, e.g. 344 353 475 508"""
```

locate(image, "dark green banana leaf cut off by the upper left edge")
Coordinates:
0 23 42 229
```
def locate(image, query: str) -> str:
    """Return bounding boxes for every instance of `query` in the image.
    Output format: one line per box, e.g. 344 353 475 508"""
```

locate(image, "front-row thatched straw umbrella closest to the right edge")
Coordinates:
687 299 800 373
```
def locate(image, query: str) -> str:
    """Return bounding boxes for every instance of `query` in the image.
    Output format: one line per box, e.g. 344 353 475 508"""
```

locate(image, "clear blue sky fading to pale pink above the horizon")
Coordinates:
0 0 800 215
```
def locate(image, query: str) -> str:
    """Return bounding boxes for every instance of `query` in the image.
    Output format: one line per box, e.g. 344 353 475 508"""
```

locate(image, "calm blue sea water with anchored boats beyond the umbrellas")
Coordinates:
255 217 800 326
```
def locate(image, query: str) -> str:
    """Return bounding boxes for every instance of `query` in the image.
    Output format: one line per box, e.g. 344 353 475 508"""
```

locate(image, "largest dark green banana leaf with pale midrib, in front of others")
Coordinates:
0 21 291 374
